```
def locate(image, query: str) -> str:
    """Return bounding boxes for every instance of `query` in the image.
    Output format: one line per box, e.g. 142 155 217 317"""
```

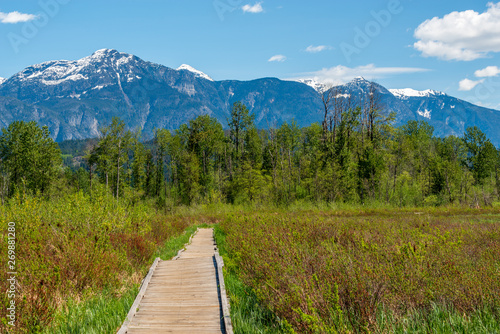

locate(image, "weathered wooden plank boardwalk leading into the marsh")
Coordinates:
118 229 232 334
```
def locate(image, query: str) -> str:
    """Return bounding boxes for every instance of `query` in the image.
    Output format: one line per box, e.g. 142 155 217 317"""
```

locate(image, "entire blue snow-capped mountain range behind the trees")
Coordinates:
0 49 500 145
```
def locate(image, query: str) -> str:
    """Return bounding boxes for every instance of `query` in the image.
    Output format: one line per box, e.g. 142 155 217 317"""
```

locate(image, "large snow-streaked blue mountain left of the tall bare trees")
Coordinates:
0 49 321 141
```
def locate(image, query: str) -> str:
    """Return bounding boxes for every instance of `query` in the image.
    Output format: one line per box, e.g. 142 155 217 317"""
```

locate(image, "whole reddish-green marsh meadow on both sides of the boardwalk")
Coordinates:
0 192 500 333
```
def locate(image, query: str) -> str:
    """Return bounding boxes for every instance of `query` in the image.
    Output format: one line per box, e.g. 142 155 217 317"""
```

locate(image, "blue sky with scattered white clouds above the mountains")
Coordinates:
0 0 500 110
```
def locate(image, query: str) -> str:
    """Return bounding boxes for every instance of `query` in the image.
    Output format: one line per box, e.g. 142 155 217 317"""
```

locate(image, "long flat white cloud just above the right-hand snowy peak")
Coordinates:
294 64 428 85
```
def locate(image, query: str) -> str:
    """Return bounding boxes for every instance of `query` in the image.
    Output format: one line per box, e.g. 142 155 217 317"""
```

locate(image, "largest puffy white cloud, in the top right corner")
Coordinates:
413 2 500 61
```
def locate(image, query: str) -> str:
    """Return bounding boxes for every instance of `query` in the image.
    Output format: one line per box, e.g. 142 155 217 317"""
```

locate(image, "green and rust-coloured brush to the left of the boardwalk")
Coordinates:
0 185 205 333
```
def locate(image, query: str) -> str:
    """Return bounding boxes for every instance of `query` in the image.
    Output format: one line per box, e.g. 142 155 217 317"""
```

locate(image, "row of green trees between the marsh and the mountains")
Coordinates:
0 86 500 206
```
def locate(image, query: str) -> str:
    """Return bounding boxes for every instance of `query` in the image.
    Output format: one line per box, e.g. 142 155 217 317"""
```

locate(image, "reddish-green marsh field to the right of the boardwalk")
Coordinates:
218 207 500 333
